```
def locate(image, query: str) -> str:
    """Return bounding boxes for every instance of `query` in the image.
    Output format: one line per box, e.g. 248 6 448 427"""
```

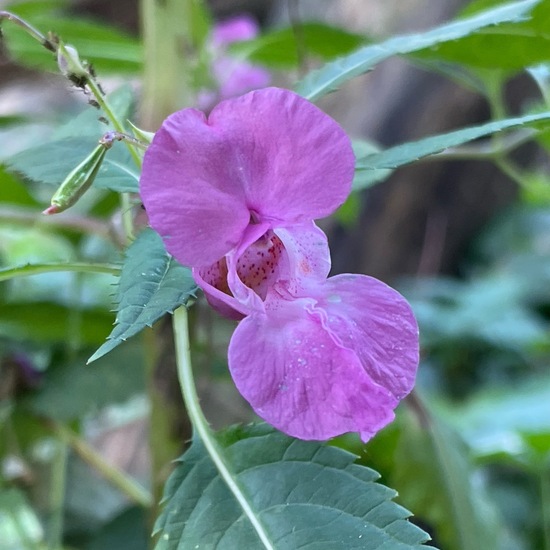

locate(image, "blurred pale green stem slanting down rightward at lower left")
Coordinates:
51 423 153 508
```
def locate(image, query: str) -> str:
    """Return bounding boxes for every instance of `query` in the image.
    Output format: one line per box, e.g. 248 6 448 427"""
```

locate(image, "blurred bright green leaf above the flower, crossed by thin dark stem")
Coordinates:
229 23 365 68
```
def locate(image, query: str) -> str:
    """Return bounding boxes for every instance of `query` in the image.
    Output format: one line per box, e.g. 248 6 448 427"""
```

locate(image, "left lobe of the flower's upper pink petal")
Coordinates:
140 109 250 266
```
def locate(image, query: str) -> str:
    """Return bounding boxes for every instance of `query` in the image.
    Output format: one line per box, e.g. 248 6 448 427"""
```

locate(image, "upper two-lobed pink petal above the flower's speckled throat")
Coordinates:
140 88 354 267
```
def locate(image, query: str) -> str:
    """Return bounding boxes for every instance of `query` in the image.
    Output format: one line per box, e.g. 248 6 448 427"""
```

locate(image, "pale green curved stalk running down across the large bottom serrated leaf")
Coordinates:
174 307 275 550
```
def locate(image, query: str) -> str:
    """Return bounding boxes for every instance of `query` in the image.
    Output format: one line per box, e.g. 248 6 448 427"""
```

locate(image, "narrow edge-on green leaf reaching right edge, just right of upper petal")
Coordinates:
355 111 550 175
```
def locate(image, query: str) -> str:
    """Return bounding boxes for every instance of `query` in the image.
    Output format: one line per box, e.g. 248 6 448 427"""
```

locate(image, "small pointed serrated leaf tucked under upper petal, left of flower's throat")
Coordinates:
88 229 201 362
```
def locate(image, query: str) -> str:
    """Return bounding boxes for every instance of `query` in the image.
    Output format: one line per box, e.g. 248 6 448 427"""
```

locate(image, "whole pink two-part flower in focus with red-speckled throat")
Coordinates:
141 88 418 441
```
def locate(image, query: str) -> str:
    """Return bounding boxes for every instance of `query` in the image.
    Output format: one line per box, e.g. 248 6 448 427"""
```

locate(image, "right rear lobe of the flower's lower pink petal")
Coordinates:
316 274 419 399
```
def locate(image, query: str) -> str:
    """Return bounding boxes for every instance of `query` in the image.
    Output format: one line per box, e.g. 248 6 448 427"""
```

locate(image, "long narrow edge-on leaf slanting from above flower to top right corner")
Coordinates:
296 0 540 101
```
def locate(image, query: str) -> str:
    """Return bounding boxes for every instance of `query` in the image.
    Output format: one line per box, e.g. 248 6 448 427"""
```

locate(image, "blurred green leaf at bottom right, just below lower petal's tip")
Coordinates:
391 415 506 550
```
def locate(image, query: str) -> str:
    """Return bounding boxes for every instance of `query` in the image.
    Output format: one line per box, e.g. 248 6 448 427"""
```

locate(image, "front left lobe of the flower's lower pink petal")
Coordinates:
229 299 398 440
